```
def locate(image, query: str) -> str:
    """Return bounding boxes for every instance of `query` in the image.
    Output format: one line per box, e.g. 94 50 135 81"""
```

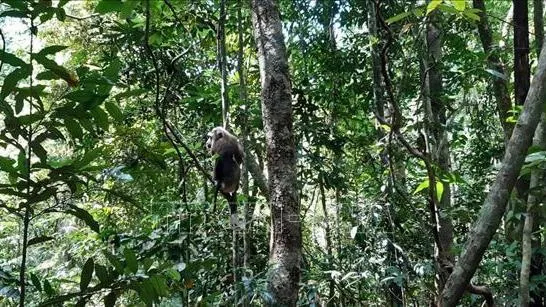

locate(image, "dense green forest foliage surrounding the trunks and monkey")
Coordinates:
0 0 546 306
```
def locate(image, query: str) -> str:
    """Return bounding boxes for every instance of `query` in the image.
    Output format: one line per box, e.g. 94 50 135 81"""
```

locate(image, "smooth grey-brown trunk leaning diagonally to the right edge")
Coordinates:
439 40 546 307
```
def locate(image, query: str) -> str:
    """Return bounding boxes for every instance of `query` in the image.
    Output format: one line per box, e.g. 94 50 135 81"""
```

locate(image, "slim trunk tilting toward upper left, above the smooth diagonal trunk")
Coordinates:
473 0 514 145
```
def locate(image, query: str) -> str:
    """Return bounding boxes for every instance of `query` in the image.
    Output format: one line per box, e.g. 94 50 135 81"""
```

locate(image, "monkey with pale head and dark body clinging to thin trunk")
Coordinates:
205 127 244 221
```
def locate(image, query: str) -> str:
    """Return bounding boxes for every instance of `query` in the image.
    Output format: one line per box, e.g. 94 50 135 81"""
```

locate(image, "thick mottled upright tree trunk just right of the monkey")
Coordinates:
252 0 301 306
